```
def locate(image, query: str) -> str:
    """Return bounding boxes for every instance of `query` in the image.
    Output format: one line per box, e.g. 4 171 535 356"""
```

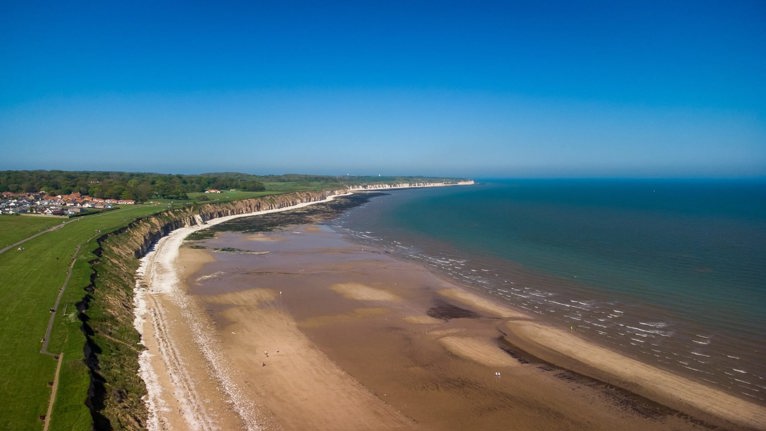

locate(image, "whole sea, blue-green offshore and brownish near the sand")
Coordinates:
331 179 766 405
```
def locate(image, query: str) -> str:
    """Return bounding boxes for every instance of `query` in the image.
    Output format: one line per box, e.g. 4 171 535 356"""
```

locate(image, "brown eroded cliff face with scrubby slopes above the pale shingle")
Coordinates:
77 192 338 430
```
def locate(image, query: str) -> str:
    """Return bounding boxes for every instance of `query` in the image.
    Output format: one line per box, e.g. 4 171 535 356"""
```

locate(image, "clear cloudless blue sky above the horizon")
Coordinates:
0 0 766 177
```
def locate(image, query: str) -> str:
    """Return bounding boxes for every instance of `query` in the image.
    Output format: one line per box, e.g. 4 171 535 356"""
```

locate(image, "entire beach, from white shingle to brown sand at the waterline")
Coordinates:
137 208 766 430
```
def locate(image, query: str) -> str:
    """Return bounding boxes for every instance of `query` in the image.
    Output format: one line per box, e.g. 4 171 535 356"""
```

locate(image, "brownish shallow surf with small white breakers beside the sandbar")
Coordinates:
340 221 763 406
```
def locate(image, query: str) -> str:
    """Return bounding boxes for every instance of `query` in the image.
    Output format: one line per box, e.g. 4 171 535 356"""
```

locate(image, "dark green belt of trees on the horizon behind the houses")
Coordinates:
0 171 265 202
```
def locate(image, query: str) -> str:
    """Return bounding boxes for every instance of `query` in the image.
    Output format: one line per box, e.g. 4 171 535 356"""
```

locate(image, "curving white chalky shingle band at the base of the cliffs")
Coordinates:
134 193 356 430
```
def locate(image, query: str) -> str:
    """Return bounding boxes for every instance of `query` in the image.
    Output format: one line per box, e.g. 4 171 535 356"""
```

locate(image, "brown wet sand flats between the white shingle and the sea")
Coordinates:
147 219 761 430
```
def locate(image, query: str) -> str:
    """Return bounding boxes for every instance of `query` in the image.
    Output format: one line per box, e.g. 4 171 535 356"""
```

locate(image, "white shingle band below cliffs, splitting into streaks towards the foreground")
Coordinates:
134 193 351 431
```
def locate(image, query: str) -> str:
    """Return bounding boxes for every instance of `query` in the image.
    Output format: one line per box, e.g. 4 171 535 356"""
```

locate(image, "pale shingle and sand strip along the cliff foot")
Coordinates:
134 193 364 430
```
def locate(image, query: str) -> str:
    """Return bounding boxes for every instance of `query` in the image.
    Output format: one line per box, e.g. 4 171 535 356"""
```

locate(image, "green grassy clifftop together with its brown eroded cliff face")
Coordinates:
0 170 468 430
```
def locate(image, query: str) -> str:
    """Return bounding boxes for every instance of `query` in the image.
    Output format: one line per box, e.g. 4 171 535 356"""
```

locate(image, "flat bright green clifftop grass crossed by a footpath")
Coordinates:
0 204 166 430
